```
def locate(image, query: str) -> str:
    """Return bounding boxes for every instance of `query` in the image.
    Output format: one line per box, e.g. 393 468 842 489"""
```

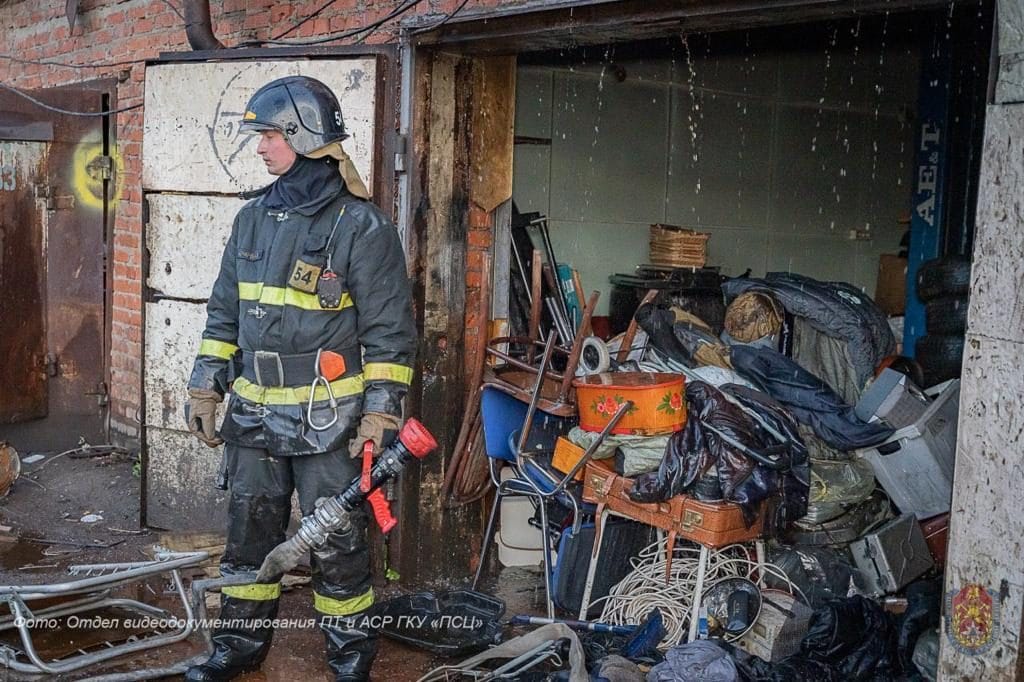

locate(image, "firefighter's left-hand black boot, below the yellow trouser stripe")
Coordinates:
185 596 278 682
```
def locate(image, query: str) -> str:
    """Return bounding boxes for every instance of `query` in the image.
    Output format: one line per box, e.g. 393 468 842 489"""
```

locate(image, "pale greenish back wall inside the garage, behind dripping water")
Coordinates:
514 35 919 314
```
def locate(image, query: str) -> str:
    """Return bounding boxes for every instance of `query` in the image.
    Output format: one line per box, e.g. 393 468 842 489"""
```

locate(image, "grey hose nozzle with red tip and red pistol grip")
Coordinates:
256 419 437 583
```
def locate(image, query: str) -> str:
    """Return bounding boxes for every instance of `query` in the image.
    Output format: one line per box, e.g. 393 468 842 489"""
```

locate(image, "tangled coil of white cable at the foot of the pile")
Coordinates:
595 541 807 651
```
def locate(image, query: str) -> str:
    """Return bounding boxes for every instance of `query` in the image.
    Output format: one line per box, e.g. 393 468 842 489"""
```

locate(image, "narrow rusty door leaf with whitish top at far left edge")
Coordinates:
0 141 49 424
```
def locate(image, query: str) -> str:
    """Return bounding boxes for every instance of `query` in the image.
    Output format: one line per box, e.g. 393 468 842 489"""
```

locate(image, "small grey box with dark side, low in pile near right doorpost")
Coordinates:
850 514 935 597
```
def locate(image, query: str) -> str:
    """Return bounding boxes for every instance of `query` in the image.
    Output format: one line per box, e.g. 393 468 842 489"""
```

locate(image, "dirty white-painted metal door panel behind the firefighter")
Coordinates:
142 57 377 529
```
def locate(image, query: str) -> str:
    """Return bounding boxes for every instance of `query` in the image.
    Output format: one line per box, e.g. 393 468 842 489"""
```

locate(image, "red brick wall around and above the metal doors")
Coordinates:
0 0 512 443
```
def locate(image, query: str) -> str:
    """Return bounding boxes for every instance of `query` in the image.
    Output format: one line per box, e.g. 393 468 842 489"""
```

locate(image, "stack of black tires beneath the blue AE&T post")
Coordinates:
914 256 971 386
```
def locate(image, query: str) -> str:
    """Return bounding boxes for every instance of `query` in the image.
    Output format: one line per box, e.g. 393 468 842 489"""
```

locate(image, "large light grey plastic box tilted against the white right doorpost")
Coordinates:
857 380 959 519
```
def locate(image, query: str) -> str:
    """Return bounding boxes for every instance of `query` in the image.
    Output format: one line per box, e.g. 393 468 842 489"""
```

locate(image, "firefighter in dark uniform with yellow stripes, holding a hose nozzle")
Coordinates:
186 76 416 680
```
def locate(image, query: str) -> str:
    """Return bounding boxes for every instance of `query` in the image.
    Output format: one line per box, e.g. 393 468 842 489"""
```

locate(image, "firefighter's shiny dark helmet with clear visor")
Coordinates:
240 76 348 156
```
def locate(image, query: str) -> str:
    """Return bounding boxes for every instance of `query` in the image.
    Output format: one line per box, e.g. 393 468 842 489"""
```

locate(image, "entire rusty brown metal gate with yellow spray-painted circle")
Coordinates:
0 82 113 452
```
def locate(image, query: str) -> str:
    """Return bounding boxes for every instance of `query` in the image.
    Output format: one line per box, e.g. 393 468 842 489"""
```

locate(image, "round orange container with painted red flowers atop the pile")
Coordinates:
573 372 686 435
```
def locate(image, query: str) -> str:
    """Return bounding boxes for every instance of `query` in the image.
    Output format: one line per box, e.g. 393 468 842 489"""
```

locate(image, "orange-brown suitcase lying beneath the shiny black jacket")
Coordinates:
583 462 764 549
